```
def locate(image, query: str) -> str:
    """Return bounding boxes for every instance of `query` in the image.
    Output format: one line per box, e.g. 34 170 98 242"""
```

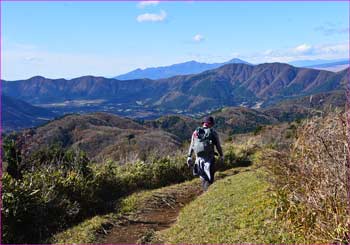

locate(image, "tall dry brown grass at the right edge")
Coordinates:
263 112 350 243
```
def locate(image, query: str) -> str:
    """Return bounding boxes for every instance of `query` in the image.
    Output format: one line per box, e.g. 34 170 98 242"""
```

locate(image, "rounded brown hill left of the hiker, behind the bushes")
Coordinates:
20 113 181 163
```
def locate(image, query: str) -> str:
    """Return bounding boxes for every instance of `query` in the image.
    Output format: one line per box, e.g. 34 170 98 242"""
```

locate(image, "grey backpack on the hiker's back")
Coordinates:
193 127 215 157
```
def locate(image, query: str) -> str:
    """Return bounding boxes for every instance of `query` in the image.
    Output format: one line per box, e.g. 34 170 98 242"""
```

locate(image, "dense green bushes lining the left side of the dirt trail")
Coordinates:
2 142 245 243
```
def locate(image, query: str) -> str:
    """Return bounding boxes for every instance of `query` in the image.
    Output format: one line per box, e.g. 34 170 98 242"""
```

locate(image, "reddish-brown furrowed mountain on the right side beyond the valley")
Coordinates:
154 63 347 111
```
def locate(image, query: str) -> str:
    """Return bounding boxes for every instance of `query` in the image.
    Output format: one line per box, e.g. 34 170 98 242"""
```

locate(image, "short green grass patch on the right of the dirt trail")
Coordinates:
154 167 293 244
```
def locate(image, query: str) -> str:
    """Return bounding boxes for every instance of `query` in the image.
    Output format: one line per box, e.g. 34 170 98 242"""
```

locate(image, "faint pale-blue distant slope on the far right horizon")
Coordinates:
289 59 349 72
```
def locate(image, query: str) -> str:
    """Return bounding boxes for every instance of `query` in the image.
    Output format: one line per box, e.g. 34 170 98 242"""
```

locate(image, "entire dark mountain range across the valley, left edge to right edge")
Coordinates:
3 63 349 121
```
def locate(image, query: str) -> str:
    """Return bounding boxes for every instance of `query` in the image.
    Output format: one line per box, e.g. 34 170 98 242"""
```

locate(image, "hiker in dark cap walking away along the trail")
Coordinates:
187 117 224 191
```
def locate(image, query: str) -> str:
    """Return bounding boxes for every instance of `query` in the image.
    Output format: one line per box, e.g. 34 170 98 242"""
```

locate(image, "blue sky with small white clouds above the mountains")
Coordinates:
1 1 349 80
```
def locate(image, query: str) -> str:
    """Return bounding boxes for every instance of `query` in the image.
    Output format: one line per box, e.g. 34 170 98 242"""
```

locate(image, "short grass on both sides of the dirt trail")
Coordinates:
51 167 295 244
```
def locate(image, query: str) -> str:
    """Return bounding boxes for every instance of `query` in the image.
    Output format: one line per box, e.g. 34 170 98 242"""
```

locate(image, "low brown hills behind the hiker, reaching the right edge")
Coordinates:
9 90 346 162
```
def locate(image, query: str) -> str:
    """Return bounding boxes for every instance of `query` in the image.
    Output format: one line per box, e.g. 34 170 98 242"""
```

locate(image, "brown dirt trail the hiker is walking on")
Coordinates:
101 170 240 244
